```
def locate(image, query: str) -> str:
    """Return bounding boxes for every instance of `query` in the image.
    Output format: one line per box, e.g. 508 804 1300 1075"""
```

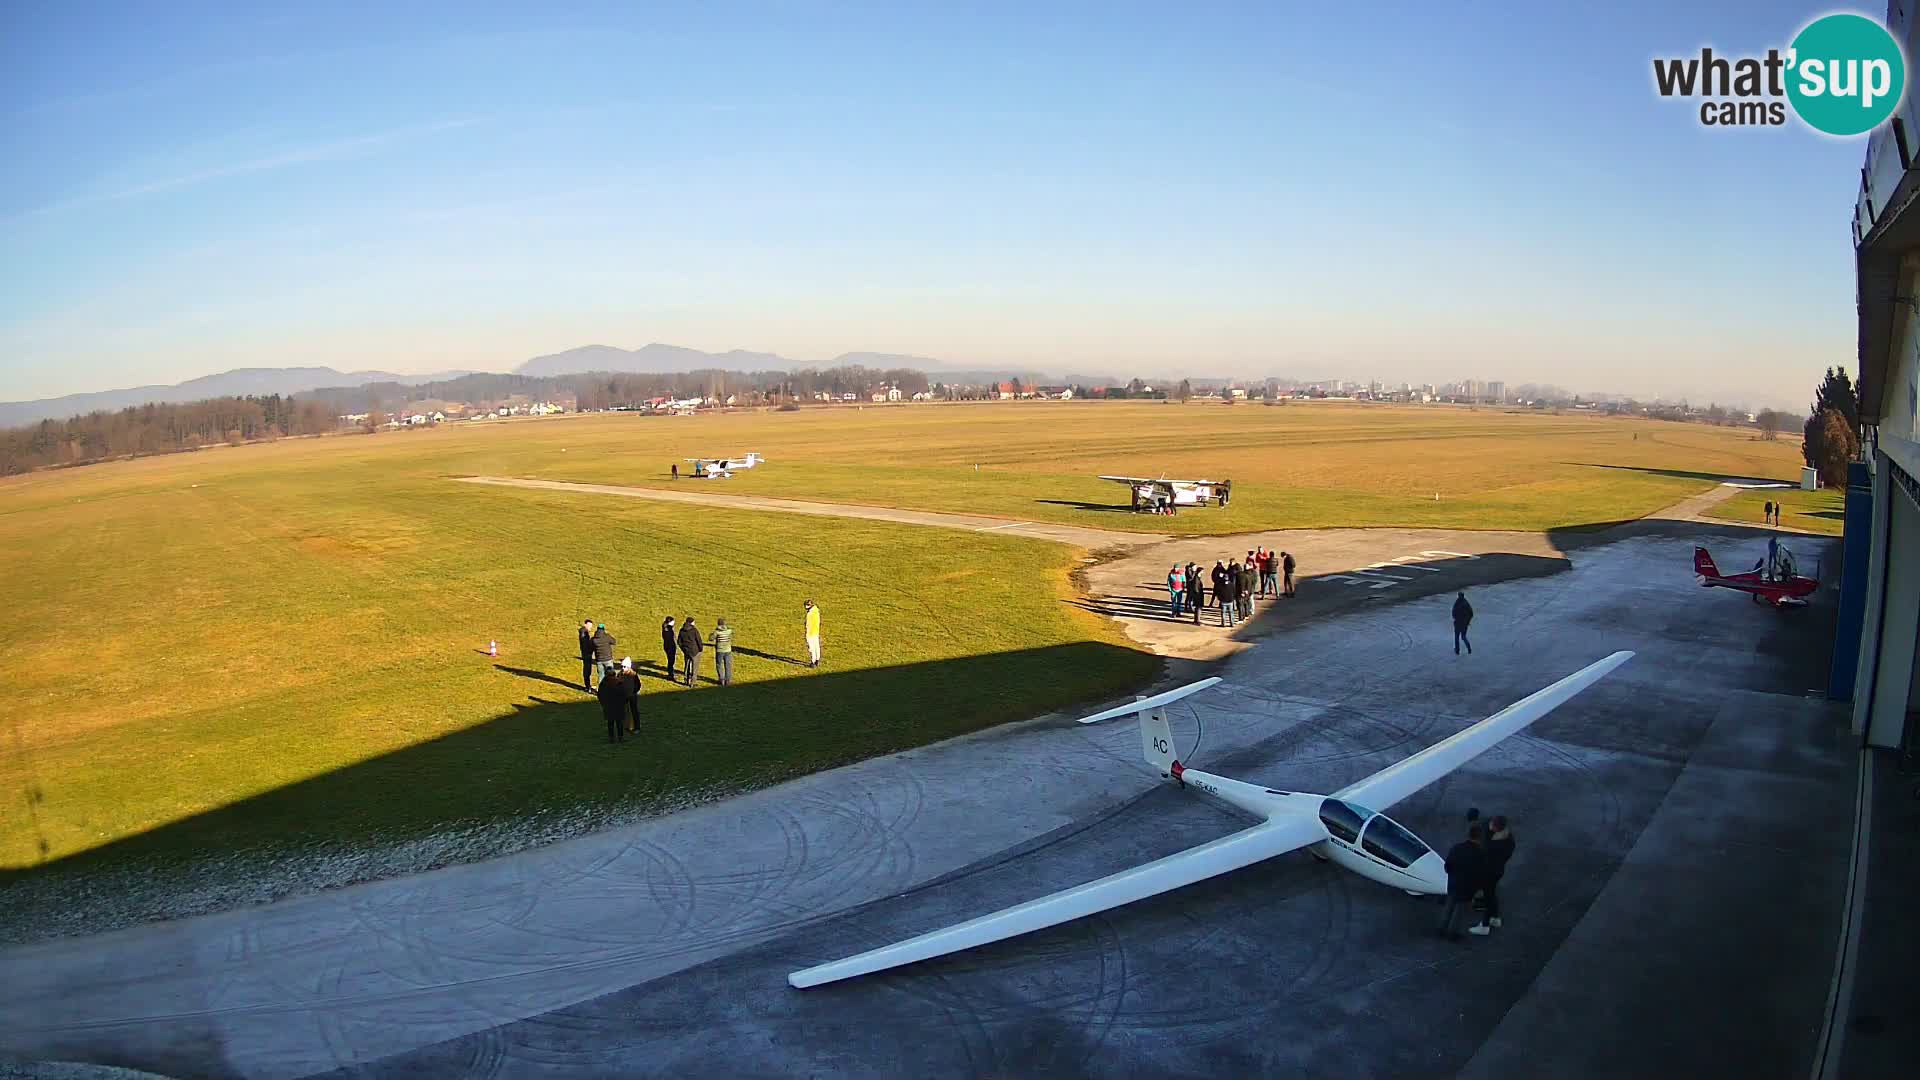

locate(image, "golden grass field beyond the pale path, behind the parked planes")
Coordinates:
480 402 1799 532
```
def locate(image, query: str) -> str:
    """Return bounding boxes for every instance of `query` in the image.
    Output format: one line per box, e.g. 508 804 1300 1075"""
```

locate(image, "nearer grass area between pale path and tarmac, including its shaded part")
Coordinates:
0 425 1154 891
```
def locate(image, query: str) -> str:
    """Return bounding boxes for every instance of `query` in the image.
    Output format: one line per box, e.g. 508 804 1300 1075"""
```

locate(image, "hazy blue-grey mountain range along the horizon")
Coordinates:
0 342 1121 427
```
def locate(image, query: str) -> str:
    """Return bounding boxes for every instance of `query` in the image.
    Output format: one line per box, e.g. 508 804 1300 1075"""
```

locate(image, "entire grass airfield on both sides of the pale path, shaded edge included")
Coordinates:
0 404 1799 934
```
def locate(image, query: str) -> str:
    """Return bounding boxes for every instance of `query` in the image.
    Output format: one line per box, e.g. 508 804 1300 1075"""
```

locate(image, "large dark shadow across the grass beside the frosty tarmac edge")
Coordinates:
0 642 1160 940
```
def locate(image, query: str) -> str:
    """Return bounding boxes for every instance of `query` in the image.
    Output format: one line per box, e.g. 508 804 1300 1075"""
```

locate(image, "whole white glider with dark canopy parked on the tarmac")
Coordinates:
787 651 1634 990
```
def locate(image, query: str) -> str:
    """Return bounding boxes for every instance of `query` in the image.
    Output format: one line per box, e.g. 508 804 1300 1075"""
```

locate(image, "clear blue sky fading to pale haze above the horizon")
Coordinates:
0 0 1884 407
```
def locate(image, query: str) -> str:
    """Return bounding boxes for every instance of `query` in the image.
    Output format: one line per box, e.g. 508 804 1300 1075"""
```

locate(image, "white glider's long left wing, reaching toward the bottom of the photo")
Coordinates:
787 817 1327 990
